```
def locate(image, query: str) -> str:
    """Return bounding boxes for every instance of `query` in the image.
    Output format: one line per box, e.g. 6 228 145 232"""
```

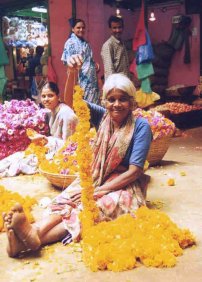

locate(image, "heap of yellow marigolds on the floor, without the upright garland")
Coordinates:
82 207 195 271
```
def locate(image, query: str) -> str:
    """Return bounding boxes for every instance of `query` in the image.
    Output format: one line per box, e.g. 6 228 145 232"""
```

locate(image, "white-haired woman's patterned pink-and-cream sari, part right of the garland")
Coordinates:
92 115 146 218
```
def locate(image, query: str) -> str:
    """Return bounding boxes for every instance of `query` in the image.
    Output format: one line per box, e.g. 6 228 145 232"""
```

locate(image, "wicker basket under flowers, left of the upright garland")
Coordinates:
39 169 77 190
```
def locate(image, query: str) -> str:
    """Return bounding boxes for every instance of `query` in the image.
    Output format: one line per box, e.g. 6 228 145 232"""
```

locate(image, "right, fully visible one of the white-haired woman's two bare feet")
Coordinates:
7 204 41 251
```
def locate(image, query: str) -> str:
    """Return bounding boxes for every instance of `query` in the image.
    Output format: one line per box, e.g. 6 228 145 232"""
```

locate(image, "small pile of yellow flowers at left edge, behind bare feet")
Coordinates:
0 185 36 231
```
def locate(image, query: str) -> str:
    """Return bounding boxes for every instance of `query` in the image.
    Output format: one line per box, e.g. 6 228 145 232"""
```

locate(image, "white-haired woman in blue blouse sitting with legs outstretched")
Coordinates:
3 70 152 257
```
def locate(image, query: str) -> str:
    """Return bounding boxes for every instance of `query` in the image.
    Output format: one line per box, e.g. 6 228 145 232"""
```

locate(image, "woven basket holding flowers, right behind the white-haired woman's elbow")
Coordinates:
147 136 172 166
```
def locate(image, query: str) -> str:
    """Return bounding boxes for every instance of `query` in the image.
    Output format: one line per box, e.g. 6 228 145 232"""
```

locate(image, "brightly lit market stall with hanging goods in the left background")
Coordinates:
2 10 48 100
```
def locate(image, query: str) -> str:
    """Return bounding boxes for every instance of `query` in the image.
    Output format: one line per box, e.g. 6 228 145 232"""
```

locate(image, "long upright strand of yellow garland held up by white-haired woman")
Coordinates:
73 86 99 234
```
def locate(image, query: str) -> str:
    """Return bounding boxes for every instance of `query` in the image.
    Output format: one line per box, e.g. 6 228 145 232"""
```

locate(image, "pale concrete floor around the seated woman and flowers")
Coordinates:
0 127 202 282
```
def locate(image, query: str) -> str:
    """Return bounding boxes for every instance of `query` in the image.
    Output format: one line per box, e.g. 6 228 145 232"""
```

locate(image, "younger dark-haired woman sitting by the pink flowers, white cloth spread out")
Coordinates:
0 82 78 177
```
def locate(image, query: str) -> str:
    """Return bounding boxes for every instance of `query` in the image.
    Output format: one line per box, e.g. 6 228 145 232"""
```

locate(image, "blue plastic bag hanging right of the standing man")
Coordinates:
136 31 154 65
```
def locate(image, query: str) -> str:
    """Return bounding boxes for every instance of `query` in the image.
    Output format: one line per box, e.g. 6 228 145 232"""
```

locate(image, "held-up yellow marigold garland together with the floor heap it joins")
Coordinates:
71 86 195 271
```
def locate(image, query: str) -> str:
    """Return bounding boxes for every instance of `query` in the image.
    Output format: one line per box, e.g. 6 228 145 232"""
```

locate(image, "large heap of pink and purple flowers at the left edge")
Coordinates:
0 99 48 160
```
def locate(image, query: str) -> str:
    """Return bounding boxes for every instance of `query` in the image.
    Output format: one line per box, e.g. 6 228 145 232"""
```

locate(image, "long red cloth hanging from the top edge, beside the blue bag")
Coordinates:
133 0 146 51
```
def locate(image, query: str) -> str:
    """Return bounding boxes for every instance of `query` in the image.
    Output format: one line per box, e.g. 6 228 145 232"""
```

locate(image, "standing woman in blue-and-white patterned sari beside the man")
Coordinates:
61 19 100 104
